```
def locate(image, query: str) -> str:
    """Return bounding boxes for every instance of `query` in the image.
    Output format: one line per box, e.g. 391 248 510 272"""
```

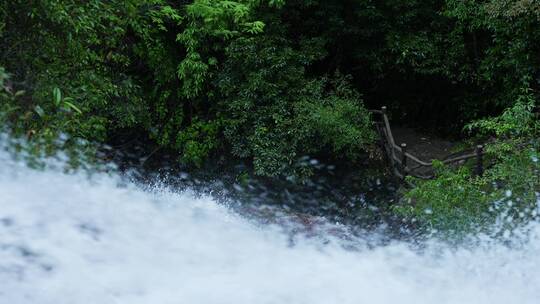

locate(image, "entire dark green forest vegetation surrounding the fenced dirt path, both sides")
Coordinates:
0 0 540 234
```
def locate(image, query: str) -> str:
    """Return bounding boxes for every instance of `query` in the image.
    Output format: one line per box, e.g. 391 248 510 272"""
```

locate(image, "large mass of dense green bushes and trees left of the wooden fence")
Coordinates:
0 0 373 176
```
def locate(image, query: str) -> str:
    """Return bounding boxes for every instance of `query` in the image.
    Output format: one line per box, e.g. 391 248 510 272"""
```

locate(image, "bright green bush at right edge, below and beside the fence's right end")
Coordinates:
395 90 540 234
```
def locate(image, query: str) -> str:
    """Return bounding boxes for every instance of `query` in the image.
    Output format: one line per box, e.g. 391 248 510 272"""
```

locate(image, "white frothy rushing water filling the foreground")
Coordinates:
0 146 540 304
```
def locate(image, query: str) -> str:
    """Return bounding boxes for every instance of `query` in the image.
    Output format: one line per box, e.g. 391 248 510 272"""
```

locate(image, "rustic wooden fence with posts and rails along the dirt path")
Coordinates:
371 107 484 179
